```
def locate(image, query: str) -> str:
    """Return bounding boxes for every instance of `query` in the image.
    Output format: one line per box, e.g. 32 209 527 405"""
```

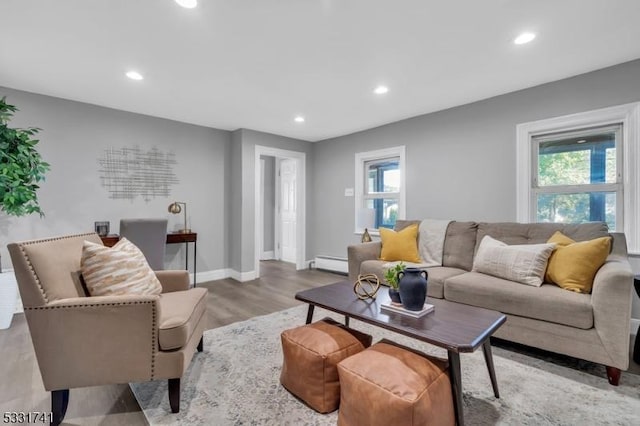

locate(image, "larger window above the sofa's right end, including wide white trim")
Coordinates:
516 103 640 254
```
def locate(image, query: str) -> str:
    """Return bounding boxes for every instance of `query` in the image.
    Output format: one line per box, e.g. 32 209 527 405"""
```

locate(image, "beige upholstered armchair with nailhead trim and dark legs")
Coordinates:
8 233 207 424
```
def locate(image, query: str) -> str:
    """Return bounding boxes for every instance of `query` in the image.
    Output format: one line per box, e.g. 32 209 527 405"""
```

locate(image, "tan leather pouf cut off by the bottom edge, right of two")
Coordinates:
338 341 455 426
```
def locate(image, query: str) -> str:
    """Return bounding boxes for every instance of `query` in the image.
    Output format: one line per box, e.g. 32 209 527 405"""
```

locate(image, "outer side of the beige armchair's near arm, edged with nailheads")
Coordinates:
25 295 160 391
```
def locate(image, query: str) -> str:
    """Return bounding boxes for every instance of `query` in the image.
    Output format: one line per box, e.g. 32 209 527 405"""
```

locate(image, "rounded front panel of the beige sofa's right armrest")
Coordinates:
591 255 633 370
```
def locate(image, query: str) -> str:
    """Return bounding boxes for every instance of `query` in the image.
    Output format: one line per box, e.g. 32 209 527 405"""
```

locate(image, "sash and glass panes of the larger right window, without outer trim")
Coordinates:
531 124 623 230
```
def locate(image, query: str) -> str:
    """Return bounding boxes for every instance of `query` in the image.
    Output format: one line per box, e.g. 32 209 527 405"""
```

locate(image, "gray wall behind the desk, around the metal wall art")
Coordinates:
0 87 230 271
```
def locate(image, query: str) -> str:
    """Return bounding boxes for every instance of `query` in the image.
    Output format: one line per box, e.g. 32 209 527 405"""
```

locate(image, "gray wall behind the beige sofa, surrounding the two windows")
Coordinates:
312 60 640 318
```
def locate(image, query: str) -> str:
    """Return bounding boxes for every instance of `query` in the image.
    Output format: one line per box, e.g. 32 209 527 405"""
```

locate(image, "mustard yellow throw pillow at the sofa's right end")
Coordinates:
545 231 611 293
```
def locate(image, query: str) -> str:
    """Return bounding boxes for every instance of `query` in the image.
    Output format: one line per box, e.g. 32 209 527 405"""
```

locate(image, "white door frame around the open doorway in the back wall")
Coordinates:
254 145 307 278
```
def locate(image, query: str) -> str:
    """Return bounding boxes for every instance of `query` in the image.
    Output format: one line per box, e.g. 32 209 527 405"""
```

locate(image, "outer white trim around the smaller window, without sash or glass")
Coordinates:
354 145 406 235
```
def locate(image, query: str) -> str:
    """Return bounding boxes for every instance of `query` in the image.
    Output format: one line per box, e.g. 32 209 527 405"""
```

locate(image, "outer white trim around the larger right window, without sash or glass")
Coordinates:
516 102 640 254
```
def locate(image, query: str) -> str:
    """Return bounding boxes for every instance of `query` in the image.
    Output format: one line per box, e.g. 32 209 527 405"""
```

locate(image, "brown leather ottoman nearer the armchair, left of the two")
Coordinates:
280 318 371 413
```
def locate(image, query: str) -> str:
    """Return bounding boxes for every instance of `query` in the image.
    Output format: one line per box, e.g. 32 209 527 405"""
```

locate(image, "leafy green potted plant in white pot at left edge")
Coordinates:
0 97 49 328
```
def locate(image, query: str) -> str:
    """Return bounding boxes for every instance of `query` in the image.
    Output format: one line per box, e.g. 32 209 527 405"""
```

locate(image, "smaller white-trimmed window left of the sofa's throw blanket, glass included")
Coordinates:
355 146 404 233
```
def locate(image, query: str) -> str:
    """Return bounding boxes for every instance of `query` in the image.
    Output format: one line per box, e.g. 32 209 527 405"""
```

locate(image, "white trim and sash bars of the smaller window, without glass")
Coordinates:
354 145 406 235
